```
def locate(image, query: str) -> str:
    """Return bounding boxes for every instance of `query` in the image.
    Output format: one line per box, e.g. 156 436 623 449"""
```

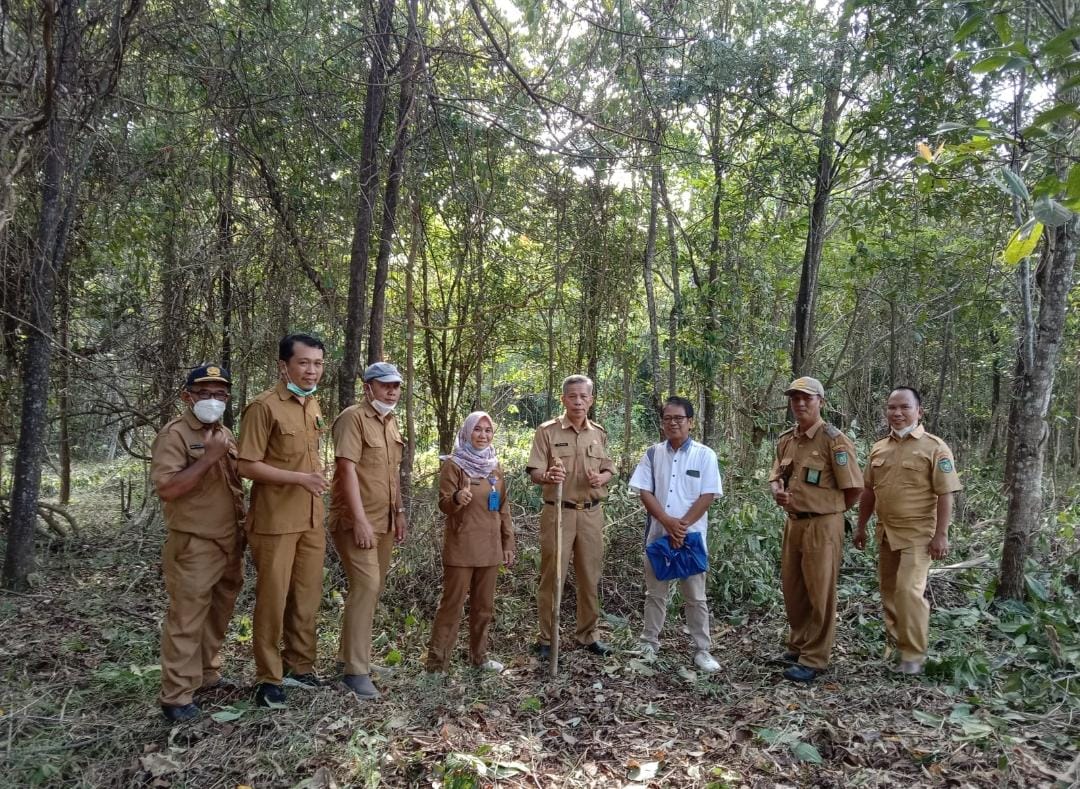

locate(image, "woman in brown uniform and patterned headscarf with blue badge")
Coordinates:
427 411 514 672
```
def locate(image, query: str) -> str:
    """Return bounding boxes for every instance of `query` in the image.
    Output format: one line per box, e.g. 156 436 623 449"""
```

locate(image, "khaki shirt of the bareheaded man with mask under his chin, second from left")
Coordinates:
240 381 326 534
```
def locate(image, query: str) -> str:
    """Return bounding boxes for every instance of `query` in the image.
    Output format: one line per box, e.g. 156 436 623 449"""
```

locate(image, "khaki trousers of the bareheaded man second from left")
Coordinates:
247 527 326 685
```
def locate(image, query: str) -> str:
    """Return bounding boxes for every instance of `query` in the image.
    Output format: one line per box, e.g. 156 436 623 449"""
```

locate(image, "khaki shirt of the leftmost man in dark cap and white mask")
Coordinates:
150 408 244 540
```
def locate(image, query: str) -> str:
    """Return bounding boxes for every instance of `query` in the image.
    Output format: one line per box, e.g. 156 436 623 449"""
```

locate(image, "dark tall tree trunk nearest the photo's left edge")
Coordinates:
3 0 79 591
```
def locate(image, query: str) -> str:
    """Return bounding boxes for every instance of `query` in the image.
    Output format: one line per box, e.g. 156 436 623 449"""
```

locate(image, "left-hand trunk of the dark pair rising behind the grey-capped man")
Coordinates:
338 0 394 408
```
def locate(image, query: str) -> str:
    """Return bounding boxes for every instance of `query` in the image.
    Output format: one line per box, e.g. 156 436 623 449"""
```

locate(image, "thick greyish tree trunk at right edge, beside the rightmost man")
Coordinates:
997 218 1080 599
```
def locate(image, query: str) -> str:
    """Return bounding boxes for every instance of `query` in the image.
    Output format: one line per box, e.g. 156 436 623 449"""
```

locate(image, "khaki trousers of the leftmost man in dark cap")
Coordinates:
159 530 244 706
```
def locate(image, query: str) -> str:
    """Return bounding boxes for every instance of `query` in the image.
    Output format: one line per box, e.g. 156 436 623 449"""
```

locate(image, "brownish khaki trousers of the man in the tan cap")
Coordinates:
780 513 843 669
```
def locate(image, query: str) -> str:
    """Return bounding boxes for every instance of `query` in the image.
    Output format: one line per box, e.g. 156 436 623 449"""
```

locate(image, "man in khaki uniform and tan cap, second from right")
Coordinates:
769 377 863 682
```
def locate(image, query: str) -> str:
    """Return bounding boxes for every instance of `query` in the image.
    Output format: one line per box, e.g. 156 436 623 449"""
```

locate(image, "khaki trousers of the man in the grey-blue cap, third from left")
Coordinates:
334 529 394 674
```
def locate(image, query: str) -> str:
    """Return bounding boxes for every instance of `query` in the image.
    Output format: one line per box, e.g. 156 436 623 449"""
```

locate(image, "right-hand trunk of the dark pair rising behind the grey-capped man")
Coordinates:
367 0 419 364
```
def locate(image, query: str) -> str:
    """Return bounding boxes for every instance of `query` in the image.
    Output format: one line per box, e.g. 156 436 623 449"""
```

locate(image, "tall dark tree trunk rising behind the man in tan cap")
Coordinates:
792 0 853 378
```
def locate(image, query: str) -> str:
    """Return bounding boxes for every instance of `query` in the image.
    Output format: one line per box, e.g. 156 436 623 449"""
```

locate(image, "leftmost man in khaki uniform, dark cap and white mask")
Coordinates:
150 365 244 721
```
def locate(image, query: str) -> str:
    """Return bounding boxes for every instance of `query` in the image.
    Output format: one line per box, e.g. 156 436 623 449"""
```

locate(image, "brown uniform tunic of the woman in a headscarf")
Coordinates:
438 460 514 567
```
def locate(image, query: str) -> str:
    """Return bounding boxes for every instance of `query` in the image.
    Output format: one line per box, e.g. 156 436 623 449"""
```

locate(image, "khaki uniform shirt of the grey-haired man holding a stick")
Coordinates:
526 413 615 504
